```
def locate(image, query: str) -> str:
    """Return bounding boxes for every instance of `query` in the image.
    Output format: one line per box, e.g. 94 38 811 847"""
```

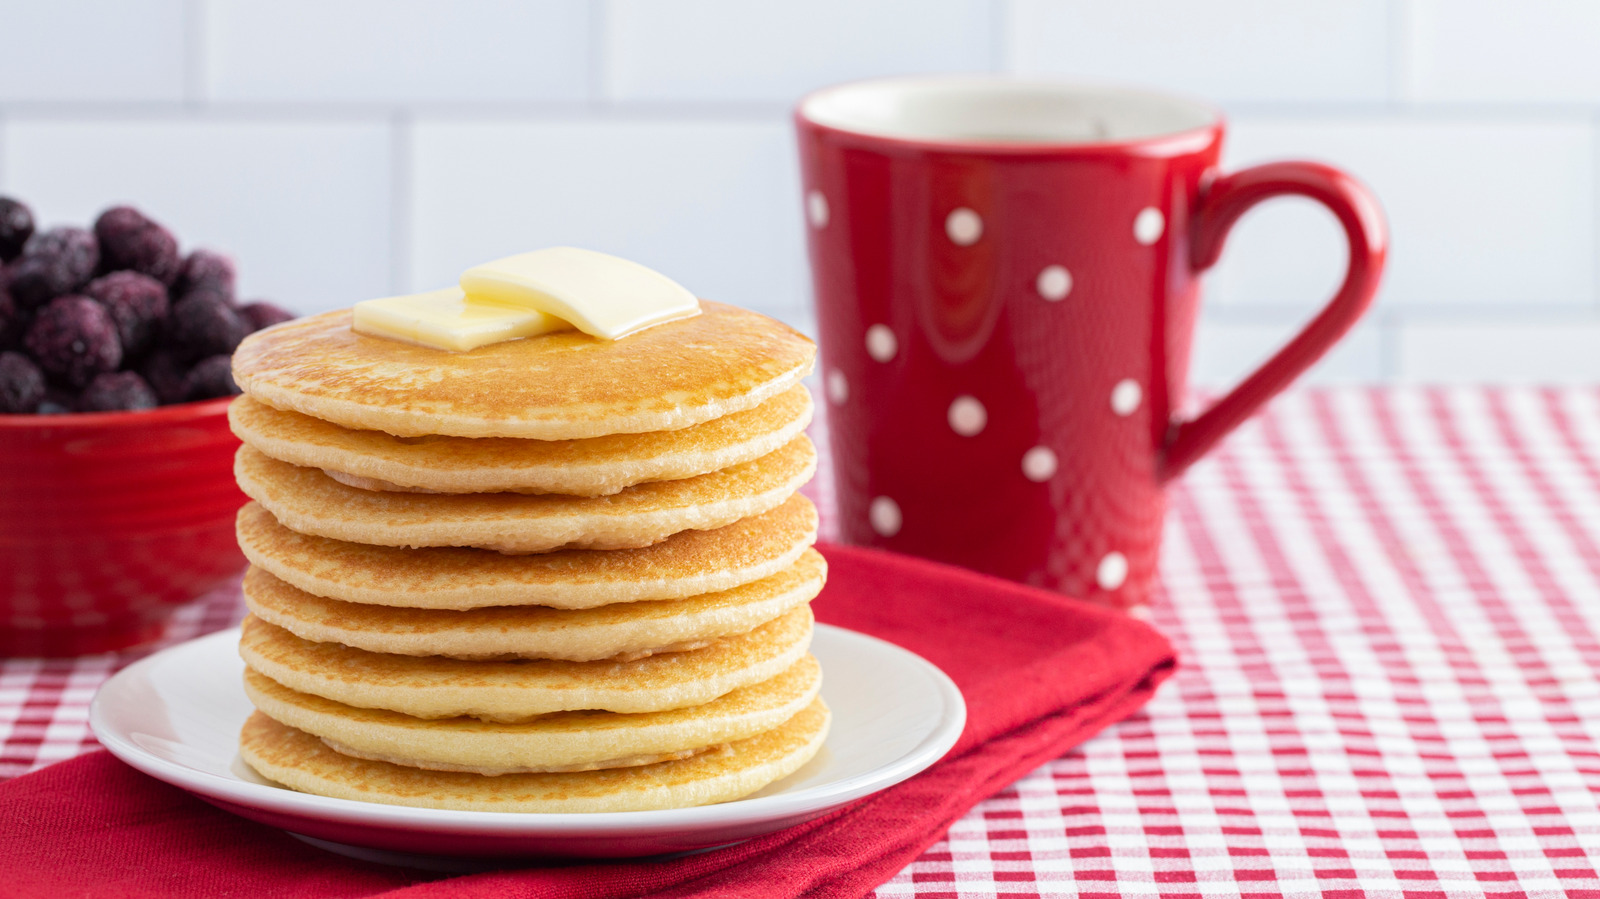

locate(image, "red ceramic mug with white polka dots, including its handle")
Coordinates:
795 77 1387 608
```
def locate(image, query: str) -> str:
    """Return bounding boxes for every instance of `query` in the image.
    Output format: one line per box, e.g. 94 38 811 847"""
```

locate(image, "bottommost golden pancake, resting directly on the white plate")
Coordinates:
238 699 829 813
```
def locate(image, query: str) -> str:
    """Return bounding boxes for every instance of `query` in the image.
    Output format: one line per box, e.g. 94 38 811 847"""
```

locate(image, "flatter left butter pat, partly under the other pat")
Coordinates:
352 288 571 352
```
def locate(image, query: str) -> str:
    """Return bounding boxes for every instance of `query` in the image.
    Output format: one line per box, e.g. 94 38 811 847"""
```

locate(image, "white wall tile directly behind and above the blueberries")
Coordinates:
3 118 390 312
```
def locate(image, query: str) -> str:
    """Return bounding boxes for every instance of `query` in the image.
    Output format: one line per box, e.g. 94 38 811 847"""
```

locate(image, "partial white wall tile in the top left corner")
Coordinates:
0 0 184 102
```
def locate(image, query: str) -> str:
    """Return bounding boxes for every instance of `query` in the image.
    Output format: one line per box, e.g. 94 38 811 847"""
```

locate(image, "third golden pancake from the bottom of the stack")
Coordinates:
238 606 811 721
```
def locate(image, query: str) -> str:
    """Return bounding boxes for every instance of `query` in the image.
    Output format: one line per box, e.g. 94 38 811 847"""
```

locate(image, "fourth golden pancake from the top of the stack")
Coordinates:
238 494 818 609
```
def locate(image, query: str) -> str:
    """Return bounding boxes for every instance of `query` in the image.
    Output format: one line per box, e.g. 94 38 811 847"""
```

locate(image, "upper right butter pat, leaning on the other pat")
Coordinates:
461 246 699 341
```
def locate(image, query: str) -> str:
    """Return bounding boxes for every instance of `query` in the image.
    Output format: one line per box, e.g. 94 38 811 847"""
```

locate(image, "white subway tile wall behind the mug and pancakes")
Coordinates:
0 0 1600 386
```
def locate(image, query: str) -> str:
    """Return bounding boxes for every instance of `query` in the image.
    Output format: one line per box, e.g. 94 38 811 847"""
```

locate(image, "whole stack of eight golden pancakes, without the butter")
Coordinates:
230 302 829 811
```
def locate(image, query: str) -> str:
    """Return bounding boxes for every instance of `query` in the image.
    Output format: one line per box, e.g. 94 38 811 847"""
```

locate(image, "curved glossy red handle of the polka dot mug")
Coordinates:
1157 162 1389 481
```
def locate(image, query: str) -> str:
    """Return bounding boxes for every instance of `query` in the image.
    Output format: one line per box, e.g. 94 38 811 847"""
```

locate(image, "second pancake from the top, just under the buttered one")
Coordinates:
227 384 811 496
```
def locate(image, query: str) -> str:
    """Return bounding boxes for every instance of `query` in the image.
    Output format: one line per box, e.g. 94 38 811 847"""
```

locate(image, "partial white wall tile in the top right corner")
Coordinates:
1403 0 1600 102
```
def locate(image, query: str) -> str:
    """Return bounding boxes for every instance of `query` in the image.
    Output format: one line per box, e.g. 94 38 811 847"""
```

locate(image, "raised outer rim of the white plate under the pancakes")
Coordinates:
88 622 966 837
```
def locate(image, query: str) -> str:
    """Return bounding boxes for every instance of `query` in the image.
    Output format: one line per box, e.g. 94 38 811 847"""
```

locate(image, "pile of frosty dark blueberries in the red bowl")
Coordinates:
0 197 293 414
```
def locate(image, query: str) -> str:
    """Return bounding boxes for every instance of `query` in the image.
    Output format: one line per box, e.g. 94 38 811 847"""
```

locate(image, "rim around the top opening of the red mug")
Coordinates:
794 74 1227 155
